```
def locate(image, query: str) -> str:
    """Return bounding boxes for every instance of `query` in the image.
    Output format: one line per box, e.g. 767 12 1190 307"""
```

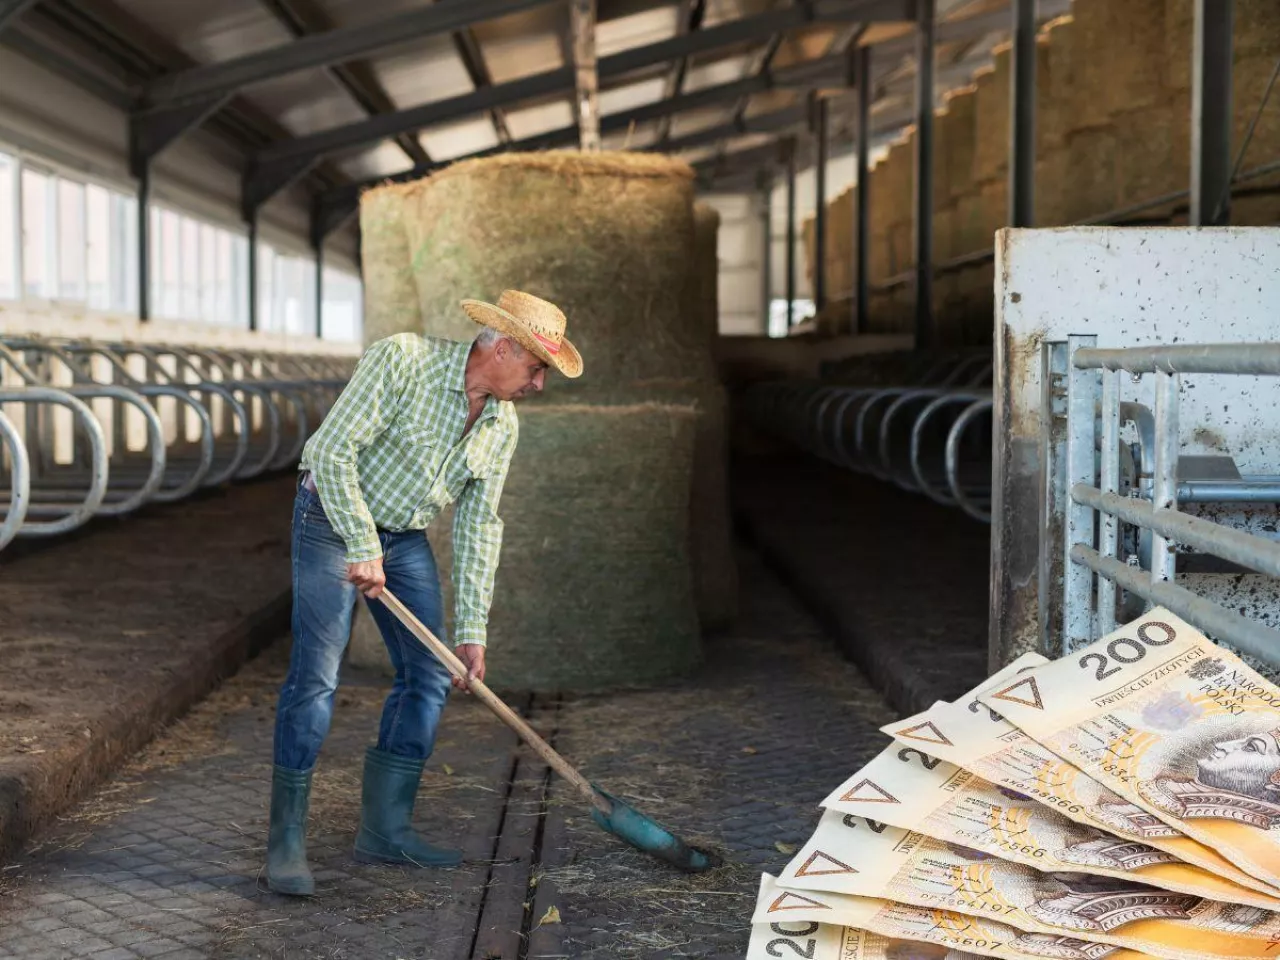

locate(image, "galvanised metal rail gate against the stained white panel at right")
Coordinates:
1039 335 1280 666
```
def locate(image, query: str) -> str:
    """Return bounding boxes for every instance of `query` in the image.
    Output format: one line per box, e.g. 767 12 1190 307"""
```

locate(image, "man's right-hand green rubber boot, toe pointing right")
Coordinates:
356 746 462 867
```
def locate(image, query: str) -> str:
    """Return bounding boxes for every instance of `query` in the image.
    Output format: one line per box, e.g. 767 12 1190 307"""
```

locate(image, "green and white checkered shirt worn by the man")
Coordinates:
300 333 520 644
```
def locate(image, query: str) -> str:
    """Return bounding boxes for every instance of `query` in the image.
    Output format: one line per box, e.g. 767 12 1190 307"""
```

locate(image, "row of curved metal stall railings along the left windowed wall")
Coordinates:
0 335 355 549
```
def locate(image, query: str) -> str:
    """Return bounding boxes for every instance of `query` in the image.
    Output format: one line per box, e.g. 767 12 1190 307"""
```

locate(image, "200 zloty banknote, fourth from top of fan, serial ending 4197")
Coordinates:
778 810 1280 960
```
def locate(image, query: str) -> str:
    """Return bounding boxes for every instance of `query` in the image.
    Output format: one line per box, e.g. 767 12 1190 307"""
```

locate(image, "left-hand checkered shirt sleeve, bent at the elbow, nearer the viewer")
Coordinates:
306 339 407 563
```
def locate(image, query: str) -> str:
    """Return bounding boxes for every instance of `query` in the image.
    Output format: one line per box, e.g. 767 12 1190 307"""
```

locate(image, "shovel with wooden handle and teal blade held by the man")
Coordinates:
378 588 717 873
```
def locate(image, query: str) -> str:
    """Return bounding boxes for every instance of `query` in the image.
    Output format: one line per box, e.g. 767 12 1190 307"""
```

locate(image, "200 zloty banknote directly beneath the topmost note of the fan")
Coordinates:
881 654 1276 899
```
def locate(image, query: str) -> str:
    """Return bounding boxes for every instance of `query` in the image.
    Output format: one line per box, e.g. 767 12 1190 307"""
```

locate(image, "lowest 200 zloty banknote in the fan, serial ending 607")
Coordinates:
746 874 1144 960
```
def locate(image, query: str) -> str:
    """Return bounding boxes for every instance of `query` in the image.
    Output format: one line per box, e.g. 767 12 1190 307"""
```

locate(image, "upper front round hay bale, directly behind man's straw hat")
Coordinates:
404 151 714 393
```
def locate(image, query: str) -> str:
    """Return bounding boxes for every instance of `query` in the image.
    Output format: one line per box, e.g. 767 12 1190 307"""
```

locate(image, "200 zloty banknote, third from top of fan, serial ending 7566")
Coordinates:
822 744 1280 910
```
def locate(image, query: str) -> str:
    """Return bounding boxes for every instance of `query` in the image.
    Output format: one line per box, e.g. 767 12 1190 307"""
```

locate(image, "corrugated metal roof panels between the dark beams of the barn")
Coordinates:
10 0 1069 204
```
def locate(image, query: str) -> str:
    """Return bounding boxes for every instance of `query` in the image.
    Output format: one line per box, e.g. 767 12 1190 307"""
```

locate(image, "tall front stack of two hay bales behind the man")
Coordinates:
348 152 732 691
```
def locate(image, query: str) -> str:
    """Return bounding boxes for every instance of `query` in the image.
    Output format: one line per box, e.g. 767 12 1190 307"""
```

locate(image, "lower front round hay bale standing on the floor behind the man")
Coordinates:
430 401 700 692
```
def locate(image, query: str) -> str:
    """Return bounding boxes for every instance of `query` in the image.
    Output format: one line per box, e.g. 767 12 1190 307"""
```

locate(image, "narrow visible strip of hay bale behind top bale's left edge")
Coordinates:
360 183 421 344
